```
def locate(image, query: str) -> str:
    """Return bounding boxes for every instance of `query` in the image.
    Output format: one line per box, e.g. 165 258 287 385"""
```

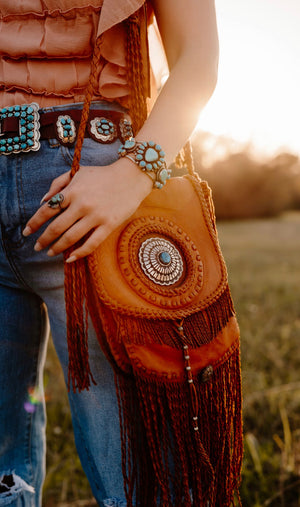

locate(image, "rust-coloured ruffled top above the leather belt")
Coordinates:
0 0 144 107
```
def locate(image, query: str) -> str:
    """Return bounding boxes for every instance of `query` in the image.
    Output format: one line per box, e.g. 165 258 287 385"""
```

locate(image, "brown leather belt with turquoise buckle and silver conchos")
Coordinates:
0 103 133 155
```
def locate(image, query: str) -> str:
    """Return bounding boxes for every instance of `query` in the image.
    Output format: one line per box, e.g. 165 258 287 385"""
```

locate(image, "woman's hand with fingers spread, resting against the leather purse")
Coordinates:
23 159 152 262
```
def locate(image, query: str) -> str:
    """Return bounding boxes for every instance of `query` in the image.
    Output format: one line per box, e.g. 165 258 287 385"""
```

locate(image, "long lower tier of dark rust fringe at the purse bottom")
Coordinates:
116 347 243 507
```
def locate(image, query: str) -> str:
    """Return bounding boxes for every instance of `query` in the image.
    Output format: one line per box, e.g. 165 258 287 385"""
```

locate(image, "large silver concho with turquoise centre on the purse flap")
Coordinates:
139 237 184 285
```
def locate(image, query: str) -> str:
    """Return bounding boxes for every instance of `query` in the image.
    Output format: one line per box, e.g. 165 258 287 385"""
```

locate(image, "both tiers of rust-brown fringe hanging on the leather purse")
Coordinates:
77 289 243 507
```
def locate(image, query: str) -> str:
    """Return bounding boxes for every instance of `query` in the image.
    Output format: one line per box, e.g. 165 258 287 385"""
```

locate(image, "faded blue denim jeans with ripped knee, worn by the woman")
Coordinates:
0 103 126 507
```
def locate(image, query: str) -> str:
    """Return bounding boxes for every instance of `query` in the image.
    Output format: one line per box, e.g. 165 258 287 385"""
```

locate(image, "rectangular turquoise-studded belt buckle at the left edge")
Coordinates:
0 102 40 155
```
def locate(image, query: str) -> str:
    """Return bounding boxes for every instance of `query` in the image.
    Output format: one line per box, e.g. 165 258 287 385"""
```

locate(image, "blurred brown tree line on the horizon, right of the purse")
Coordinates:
173 132 300 219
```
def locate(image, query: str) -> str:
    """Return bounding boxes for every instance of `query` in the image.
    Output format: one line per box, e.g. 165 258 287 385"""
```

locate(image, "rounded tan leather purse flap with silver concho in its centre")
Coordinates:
88 175 227 319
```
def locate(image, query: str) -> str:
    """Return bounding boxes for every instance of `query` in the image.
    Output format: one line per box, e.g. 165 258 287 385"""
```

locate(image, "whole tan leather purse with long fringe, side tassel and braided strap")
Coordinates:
65 13 242 507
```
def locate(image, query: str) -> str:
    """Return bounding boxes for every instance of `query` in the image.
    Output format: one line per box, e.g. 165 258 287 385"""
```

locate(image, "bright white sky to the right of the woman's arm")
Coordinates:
197 0 300 155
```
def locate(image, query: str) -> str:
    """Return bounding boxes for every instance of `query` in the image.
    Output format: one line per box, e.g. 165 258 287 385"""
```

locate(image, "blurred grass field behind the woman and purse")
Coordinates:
44 213 300 507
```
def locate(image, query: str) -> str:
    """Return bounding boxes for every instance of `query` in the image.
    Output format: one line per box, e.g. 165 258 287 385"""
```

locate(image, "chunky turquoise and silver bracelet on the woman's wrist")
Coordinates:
119 138 171 188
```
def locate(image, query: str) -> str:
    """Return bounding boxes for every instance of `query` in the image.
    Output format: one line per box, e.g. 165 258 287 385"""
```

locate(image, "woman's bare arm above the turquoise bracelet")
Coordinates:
136 0 218 163
